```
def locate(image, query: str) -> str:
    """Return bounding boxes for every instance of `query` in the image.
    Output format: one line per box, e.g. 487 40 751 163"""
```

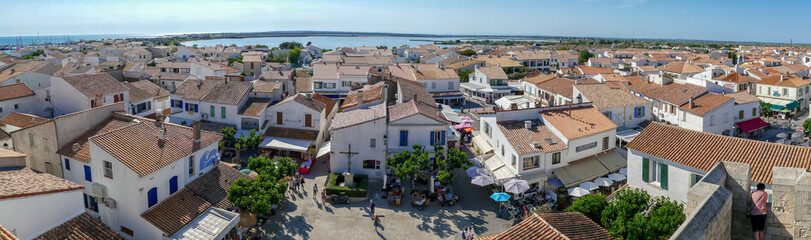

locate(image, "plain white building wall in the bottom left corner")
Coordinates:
0 190 84 239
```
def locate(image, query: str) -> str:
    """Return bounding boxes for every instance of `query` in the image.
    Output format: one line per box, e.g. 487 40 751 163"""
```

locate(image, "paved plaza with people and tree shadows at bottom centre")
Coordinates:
262 155 514 239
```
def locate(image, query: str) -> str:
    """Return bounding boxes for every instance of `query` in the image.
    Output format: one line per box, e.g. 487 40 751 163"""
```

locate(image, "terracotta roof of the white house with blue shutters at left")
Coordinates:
90 118 222 177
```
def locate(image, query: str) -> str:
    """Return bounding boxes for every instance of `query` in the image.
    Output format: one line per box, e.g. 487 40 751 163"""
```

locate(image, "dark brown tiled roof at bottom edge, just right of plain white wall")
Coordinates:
34 213 125 240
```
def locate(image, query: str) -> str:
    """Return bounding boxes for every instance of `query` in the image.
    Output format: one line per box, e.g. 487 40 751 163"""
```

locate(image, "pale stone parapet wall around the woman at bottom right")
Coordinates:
670 162 811 240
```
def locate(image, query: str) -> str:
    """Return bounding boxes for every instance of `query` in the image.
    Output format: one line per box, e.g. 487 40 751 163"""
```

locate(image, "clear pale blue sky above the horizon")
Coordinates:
0 0 811 43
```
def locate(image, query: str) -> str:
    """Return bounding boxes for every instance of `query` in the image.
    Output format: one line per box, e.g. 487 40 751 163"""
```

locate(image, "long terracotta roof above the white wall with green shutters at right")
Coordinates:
627 122 811 184
